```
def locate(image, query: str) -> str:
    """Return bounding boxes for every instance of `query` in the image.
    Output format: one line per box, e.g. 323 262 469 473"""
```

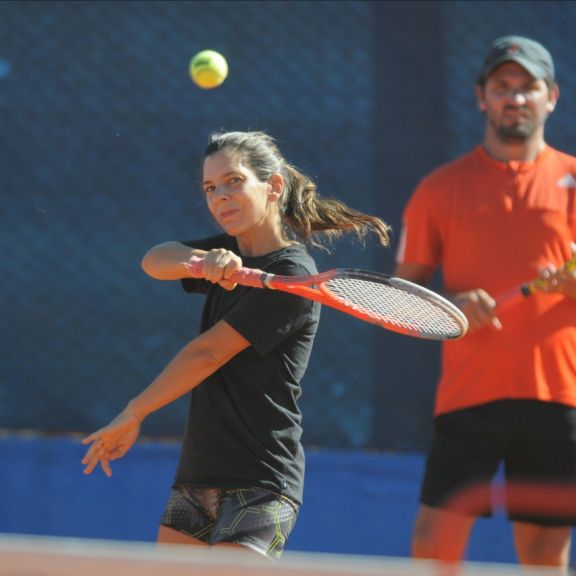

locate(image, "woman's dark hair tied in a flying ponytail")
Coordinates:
204 132 390 246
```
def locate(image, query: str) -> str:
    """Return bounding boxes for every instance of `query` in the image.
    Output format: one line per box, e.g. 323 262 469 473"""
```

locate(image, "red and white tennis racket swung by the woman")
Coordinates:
185 256 468 340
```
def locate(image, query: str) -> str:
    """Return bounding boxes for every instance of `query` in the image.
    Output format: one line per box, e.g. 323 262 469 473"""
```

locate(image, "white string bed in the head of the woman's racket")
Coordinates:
323 277 462 337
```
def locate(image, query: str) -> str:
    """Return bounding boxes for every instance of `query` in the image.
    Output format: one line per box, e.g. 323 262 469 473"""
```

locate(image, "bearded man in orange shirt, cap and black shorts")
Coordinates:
395 36 576 566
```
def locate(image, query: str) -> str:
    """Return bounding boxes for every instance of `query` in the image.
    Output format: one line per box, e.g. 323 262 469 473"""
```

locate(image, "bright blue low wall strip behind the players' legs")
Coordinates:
0 436 515 562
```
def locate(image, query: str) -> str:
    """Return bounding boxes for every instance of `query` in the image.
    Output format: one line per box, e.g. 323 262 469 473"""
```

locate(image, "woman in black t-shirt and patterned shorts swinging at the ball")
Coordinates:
82 132 388 558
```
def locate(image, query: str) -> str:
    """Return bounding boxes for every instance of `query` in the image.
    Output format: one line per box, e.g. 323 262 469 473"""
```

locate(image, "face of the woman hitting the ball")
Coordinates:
202 149 278 238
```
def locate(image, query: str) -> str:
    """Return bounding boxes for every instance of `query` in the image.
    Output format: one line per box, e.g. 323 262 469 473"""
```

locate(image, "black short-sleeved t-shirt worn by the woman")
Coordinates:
176 235 320 502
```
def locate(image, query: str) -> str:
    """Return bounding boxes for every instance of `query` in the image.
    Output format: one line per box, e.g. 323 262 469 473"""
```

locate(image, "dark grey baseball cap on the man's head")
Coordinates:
478 36 554 83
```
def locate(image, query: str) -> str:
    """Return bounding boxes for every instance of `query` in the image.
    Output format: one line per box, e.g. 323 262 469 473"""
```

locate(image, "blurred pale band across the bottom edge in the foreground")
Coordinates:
0 534 558 576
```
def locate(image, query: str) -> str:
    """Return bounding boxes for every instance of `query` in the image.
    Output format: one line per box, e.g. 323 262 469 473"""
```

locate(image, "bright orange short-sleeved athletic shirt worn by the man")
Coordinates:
398 146 576 415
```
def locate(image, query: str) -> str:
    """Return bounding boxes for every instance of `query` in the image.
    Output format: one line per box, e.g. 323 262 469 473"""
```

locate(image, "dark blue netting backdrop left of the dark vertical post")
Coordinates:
0 1 375 445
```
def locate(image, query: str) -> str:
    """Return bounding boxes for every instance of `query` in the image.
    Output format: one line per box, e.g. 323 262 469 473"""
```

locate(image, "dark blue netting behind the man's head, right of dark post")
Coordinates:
443 1 576 156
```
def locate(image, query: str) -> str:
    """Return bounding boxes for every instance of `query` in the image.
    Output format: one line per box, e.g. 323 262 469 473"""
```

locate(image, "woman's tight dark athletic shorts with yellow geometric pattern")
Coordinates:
160 485 299 558
